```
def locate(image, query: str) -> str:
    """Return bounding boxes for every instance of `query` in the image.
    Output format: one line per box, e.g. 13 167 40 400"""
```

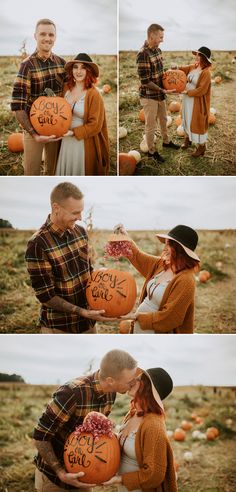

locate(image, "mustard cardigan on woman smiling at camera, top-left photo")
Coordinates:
63 84 110 176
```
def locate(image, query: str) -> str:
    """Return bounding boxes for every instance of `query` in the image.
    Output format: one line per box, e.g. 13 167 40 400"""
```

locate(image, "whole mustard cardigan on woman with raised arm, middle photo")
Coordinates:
129 243 195 333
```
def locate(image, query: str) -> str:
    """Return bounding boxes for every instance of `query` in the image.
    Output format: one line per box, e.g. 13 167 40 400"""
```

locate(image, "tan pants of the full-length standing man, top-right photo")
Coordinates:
140 98 169 154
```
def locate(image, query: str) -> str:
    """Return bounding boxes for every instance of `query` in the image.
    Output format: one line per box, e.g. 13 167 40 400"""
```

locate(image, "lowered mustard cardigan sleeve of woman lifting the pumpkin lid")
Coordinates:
137 275 195 333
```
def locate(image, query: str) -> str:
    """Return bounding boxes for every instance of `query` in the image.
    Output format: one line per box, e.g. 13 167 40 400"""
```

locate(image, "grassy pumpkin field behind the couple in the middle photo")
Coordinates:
0 227 236 334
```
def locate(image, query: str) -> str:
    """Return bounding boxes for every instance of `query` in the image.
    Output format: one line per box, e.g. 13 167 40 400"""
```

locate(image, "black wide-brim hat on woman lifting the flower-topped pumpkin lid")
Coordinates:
156 225 200 261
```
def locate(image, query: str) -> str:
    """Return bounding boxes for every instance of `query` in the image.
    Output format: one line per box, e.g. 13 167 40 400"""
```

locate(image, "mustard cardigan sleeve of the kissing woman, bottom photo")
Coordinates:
122 419 167 490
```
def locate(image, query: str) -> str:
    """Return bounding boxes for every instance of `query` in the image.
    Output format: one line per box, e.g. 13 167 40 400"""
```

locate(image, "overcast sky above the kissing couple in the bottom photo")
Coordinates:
0 335 236 386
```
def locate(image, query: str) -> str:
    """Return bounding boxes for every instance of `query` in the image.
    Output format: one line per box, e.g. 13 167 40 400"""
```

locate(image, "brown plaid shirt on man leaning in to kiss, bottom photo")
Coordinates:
33 371 116 490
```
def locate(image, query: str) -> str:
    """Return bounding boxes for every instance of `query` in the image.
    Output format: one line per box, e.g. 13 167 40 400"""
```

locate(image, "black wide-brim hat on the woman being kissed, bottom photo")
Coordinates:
137 367 173 410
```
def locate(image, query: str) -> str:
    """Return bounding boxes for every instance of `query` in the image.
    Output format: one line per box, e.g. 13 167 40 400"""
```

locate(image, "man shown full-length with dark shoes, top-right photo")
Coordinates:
137 24 179 162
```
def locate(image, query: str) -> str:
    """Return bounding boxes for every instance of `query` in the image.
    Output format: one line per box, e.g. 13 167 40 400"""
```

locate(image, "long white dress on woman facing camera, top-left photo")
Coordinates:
55 91 85 176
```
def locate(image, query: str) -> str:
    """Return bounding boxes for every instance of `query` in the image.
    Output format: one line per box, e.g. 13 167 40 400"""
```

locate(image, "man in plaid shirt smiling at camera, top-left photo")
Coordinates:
11 19 65 176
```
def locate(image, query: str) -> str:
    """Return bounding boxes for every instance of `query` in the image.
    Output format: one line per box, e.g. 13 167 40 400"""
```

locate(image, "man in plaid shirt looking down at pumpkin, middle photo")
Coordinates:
26 182 113 333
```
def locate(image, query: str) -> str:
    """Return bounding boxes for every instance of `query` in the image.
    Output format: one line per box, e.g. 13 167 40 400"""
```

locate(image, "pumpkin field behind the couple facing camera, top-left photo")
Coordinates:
0 55 117 176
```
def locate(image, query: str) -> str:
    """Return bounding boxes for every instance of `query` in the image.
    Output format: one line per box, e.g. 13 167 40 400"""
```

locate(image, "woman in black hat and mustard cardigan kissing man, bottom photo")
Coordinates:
105 368 177 492
